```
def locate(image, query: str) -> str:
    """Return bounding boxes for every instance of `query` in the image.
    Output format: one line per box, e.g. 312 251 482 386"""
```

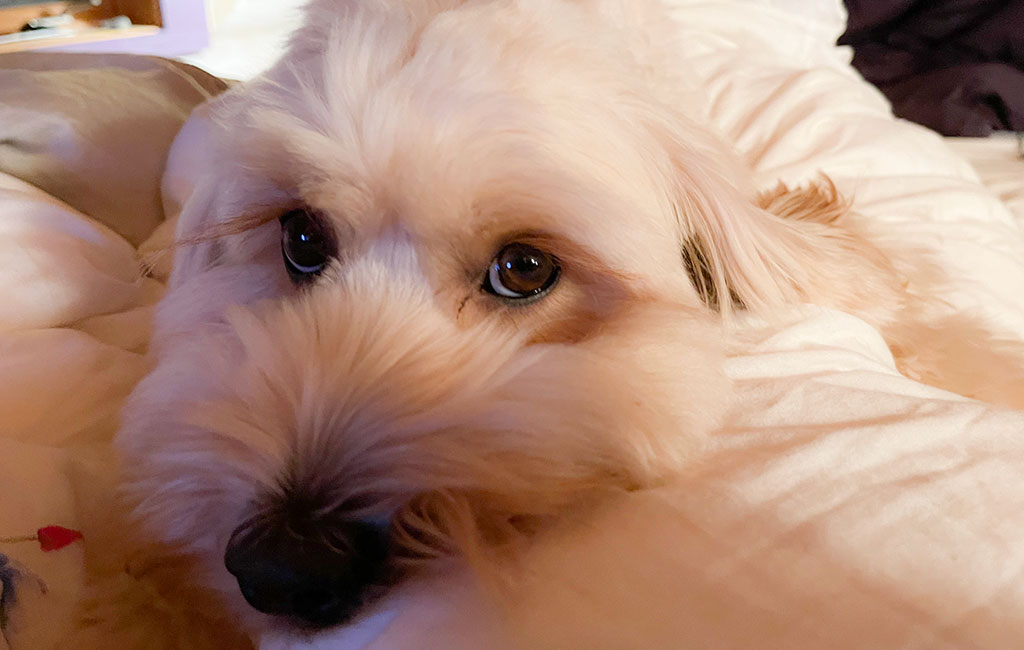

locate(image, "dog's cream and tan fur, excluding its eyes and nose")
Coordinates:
61 0 1024 647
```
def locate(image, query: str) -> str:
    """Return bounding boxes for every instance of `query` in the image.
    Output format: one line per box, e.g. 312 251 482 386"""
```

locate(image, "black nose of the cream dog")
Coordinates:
224 514 387 627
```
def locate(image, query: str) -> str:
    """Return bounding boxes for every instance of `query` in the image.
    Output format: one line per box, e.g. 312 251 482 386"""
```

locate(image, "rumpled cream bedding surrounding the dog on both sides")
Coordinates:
0 0 1024 650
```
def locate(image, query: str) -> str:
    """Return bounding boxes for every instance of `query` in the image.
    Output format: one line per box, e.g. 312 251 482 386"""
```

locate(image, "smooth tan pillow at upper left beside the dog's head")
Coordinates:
0 52 226 245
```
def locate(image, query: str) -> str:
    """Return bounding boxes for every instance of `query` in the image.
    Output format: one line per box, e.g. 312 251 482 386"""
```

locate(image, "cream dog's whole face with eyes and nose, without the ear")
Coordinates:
119 0 749 625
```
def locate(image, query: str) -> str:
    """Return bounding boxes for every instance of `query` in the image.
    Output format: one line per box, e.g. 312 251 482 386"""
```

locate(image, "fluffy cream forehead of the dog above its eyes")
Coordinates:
214 3 688 268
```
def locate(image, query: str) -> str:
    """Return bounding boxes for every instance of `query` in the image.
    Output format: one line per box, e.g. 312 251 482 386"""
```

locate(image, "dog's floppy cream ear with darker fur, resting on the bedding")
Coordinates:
657 120 896 317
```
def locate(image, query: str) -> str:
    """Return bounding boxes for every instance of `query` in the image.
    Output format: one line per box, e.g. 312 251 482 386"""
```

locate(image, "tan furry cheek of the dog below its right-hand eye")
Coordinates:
387 307 730 563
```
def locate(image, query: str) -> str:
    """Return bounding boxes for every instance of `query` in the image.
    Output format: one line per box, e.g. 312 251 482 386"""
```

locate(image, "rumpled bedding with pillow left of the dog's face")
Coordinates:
0 54 224 650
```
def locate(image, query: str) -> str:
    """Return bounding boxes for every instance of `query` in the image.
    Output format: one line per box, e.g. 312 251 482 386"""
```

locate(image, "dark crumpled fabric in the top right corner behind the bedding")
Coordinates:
840 0 1024 136
